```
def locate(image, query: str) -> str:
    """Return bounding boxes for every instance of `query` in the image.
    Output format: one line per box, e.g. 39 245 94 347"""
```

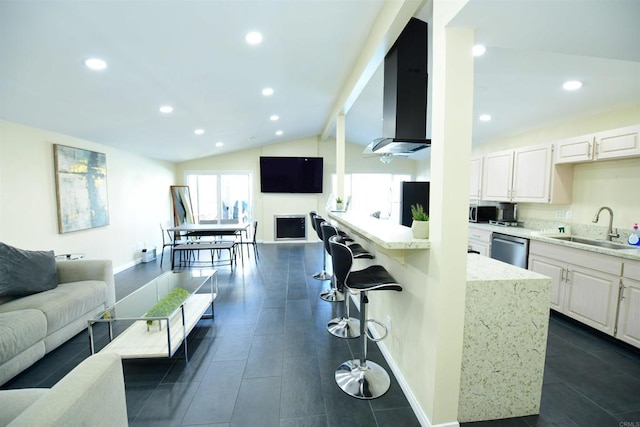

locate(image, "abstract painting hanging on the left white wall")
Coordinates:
53 144 109 233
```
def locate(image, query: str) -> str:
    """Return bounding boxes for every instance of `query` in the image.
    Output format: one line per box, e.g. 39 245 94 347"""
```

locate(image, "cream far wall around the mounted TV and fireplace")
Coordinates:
178 137 415 242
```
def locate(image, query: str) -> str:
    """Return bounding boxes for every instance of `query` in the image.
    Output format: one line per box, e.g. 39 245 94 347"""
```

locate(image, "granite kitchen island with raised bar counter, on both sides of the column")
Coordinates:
328 213 551 422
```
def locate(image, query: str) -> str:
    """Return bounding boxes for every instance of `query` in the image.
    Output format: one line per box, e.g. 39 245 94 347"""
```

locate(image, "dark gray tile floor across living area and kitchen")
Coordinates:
2 243 640 427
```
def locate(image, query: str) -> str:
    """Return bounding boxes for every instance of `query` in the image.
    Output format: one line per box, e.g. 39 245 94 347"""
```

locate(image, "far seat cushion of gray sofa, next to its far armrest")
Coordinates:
0 280 107 335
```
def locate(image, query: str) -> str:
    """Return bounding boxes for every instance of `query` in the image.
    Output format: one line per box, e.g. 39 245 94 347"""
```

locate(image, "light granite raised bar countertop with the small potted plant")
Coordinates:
328 212 431 249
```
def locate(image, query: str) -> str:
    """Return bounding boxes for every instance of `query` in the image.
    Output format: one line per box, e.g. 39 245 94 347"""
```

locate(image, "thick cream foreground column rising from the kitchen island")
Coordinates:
424 0 473 425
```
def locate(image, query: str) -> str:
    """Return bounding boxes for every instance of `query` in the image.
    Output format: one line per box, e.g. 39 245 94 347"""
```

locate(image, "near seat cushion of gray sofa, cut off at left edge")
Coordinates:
0 310 47 364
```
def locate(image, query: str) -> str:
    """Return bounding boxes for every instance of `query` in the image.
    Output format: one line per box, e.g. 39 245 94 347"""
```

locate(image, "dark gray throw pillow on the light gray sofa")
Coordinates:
0 242 58 297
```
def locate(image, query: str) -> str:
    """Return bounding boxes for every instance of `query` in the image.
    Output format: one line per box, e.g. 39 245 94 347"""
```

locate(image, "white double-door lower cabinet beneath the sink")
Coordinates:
529 241 622 335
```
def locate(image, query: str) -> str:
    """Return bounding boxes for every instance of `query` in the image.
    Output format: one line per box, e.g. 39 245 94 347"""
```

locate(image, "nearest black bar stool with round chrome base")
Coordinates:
329 237 402 399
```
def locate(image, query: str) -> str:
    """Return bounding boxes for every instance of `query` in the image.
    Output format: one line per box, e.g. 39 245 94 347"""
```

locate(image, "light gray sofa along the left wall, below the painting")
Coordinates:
0 260 115 385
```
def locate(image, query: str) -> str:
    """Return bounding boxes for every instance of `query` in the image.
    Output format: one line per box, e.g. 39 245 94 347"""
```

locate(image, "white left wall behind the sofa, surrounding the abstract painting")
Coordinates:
0 121 175 271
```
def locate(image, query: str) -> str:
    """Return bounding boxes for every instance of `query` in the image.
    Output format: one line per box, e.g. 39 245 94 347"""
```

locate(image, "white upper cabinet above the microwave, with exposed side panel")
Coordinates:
482 144 573 203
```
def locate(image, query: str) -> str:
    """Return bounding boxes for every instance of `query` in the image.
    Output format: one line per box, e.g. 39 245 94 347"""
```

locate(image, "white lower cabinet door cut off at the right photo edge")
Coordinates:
616 260 640 347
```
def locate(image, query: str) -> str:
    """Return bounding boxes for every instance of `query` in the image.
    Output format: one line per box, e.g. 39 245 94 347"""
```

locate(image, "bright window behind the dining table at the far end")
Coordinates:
185 171 251 223
